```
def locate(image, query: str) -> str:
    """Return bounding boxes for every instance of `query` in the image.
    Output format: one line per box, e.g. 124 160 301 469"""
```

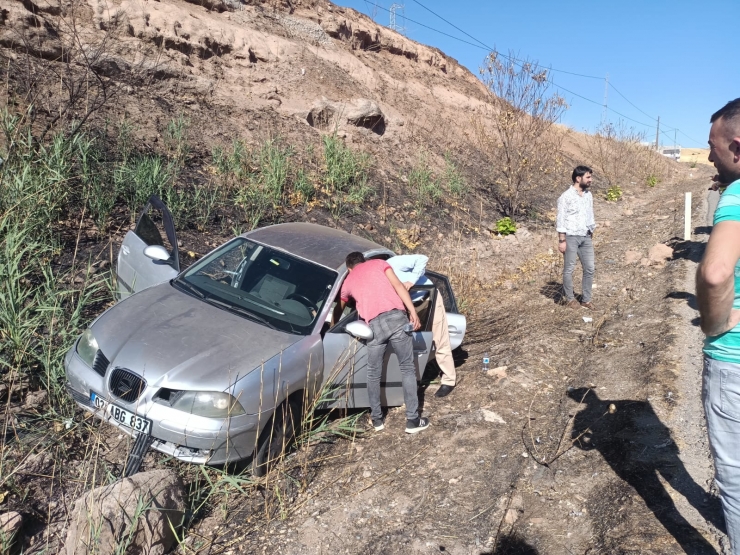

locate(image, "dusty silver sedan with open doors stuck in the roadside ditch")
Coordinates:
65 197 466 473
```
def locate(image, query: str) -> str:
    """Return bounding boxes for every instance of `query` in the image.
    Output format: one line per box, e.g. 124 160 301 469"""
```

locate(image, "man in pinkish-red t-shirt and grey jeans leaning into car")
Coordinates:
334 252 429 434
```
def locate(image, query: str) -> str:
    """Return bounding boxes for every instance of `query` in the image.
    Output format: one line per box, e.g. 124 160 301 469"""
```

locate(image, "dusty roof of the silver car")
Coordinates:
244 222 392 270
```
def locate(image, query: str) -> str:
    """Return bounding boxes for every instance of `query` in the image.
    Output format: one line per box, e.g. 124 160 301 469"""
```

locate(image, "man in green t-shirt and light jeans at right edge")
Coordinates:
696 98 740 555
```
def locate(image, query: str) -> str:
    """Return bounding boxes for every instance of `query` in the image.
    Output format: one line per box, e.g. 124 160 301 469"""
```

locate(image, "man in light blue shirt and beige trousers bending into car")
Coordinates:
387 254 457 397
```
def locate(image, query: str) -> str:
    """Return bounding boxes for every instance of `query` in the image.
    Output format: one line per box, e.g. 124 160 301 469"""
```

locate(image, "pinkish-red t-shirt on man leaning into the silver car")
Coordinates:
339 260 406 322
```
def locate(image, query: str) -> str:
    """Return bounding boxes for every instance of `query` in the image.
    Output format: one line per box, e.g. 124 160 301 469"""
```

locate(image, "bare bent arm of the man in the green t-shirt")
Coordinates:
696 220 740 337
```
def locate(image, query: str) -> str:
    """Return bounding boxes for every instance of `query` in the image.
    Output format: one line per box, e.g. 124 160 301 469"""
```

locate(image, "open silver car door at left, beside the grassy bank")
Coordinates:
116 195 180 300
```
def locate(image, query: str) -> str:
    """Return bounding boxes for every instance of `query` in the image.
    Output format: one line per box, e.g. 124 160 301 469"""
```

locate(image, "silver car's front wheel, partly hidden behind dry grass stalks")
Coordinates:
252 393 303 477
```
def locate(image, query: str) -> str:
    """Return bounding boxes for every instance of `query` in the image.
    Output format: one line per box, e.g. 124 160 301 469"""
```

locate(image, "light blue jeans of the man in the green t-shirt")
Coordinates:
702 356 740 554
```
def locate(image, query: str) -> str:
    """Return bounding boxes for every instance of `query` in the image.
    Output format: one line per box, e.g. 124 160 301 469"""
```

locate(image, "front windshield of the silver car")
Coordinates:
174 238 337 335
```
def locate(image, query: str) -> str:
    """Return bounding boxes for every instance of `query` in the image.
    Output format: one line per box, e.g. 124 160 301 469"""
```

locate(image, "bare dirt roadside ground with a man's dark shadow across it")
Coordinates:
169 166 721 555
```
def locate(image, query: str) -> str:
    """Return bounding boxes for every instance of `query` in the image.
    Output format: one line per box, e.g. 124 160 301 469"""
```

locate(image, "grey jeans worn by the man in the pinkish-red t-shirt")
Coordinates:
367 310 419 420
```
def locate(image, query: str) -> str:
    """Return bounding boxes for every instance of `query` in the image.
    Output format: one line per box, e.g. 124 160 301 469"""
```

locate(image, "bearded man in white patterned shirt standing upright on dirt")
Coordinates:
556 166 596 309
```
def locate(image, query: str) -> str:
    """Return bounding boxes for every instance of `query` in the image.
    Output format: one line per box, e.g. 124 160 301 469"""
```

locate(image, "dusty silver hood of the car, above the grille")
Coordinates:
92 283 303 390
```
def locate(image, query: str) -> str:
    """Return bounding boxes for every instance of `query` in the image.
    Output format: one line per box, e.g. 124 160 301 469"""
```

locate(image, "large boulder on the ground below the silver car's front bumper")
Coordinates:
64 470 185 555
